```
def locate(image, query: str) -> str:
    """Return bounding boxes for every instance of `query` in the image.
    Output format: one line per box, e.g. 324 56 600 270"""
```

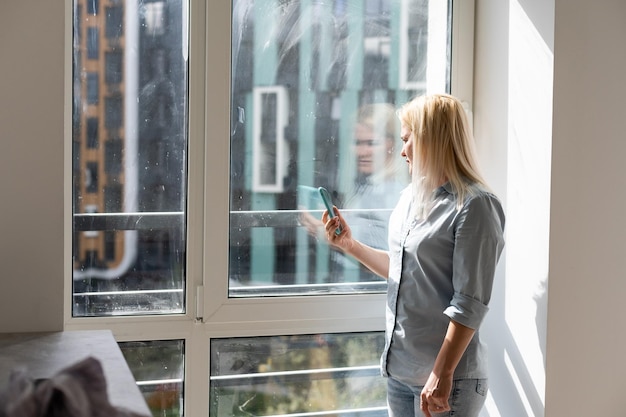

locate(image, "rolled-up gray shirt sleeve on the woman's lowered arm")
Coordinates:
444 194 504 329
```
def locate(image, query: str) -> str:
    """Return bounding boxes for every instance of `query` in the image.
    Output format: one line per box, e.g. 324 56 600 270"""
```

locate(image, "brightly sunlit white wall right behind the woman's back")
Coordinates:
474 0 554 417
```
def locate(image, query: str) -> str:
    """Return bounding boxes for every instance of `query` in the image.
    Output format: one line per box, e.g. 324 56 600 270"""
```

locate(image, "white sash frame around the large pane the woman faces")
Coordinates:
200 1 474 332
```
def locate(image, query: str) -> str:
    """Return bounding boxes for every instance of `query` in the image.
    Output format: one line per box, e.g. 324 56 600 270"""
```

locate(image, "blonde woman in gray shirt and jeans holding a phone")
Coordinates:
322 94 504 417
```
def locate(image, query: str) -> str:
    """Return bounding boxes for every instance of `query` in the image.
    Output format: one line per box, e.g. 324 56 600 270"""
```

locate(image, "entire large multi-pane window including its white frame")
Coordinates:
66 0 473 417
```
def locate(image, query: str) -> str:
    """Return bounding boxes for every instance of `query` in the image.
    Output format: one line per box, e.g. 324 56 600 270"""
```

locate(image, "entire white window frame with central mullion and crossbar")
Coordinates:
64 0 474 416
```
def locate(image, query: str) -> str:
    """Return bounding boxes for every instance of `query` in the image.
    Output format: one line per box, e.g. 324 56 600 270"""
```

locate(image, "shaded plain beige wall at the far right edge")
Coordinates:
546 0 626 417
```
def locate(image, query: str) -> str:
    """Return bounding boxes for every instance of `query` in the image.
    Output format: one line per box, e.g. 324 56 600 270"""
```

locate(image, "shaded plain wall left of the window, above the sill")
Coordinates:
0 0 65 332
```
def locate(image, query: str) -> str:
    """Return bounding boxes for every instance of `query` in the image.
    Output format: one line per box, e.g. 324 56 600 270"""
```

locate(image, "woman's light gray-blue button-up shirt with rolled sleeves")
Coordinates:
381 183 504 386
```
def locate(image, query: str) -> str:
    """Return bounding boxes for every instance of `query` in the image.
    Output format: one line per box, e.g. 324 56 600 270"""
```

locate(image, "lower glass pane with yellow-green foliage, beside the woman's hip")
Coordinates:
209 332 387 417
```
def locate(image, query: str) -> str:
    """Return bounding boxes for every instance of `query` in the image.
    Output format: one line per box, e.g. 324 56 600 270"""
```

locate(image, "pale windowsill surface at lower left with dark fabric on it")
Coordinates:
0 330 151 416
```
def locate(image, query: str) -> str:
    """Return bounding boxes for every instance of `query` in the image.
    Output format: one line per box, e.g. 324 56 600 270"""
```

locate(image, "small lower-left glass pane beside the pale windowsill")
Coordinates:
118 340 185 417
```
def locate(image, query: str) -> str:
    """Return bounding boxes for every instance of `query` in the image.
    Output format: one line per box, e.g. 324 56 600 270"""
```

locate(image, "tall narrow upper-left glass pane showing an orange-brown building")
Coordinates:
72 0 188 316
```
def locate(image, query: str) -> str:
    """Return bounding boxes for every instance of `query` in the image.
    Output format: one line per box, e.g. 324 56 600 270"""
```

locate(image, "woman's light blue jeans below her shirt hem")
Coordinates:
387 378 487 417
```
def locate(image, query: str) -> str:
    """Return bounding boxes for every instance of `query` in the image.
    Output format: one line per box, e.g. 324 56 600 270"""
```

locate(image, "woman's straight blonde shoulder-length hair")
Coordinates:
398 94 487 218
